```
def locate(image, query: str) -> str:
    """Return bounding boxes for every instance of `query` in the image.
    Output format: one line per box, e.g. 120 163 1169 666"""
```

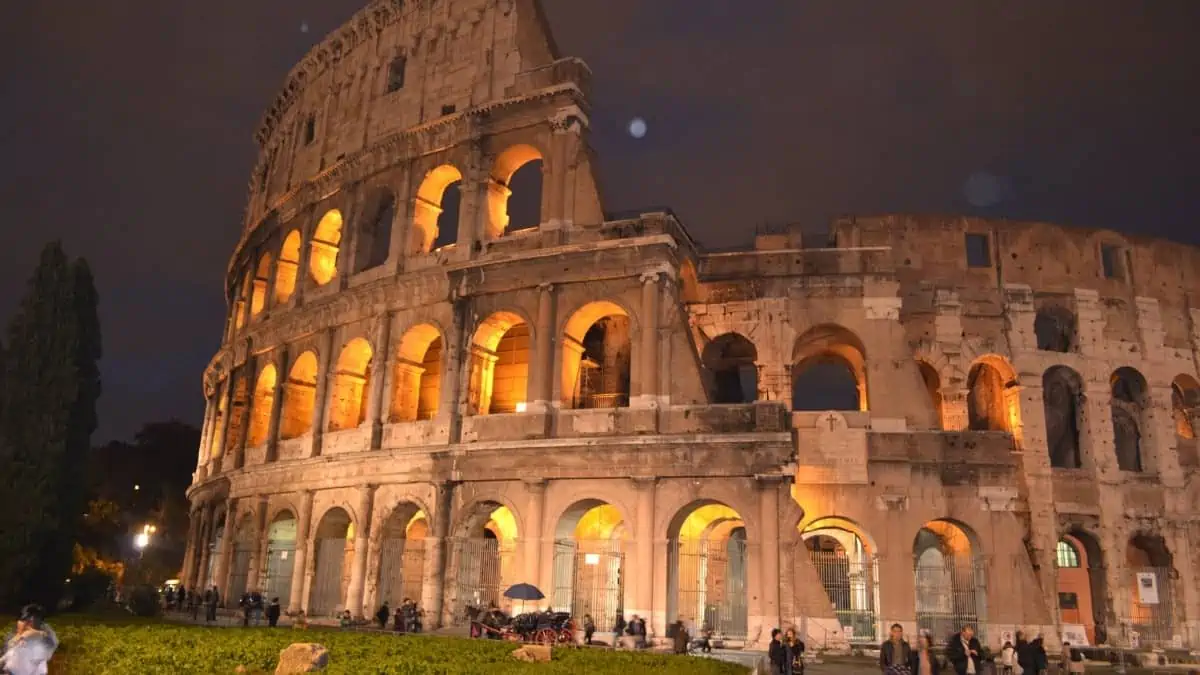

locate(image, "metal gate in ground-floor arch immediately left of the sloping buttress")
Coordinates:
668 538 748 640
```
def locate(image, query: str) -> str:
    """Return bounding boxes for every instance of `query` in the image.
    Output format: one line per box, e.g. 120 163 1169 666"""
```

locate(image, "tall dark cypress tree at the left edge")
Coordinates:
0 243 101 608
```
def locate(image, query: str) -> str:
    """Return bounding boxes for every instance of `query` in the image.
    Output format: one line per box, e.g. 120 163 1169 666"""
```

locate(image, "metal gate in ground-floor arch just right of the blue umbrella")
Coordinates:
553 539 625 631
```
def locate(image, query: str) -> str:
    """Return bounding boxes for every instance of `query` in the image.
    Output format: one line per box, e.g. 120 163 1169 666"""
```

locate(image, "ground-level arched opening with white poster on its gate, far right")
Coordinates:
1126 534 1175 647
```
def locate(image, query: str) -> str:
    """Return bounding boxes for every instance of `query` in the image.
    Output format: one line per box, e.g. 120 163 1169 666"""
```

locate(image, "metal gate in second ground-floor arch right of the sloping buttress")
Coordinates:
913 560 988 644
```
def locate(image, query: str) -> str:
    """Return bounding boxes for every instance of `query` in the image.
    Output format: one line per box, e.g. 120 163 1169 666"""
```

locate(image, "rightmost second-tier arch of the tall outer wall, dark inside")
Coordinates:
562 300 632 408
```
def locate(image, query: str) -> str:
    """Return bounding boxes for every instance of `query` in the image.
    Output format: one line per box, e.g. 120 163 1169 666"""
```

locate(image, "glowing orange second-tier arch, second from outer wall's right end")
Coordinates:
467 312 530 414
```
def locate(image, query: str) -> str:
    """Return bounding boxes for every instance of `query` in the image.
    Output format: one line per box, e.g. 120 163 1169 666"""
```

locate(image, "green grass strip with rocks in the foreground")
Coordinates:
50 616 748 675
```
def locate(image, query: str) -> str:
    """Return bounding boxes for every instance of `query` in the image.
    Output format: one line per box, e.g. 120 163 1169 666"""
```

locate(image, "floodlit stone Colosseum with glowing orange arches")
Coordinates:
181 0 1200 649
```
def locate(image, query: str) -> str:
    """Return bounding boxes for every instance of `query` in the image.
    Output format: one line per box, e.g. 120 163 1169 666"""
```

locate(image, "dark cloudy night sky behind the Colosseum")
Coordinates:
0 0 1200 441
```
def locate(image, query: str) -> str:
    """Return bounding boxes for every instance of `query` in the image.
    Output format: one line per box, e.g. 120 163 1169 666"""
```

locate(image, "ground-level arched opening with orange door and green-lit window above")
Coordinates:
1055 530 1108 645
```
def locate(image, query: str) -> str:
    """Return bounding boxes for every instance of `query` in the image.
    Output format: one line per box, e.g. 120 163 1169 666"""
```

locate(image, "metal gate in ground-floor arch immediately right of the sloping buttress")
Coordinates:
793 548 880 643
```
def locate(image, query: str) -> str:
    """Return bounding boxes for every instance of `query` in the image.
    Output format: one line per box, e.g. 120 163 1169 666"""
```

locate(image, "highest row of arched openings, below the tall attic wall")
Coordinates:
230 144 542 331
